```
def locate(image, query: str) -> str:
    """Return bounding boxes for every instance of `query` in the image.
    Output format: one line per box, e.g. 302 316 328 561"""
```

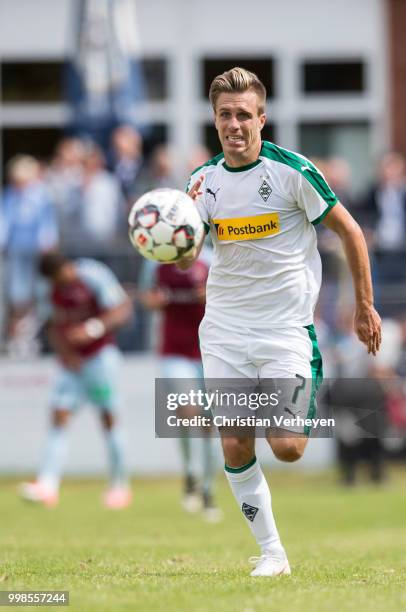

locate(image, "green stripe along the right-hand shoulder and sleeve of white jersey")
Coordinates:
260 140 337 214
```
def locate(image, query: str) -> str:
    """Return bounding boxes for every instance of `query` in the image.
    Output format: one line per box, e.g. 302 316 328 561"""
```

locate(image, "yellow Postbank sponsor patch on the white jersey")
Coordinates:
213 213 280 241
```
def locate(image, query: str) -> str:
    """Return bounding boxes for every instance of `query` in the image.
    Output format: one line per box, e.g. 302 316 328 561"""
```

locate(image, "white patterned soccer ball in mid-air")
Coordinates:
128 189 204 263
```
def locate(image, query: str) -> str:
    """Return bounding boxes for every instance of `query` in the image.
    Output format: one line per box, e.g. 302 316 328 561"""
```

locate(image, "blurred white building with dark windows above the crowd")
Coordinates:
0 0 406 190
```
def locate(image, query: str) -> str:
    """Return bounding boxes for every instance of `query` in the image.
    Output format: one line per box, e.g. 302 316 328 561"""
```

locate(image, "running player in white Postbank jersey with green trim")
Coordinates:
178 68 381 576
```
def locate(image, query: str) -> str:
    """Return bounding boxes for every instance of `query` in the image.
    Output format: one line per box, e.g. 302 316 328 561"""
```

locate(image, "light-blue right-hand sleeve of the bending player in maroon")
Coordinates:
77 260 127 309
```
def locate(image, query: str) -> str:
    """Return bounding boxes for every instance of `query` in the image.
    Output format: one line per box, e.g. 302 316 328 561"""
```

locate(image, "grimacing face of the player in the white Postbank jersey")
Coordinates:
214 91 266 166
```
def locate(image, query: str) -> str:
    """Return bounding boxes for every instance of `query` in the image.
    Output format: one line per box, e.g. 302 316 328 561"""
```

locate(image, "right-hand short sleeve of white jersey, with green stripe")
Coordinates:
297 162 338 225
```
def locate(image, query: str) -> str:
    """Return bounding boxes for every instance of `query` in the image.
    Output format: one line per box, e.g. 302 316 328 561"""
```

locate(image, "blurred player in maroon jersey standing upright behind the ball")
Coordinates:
141 258 222 522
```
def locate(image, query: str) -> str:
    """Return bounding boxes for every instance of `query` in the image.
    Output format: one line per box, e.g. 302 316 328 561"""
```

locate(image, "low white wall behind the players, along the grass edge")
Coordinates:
0 354 334 477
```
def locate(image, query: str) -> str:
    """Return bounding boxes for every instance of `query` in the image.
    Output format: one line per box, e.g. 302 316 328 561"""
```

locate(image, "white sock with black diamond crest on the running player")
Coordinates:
225 457 286 557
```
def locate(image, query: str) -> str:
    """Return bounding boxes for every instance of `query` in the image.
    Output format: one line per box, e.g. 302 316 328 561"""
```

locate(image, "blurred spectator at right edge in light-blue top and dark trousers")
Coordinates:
360 153 406 315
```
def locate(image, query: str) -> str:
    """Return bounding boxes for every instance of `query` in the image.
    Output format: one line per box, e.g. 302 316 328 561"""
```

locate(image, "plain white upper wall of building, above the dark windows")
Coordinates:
0 0 385 57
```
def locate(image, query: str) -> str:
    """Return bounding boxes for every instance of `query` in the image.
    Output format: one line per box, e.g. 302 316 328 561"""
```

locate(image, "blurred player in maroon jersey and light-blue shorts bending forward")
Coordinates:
21 253 131 509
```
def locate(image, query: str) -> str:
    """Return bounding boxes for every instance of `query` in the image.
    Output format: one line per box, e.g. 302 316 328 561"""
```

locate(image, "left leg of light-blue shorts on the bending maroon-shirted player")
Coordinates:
49 365 84 413
